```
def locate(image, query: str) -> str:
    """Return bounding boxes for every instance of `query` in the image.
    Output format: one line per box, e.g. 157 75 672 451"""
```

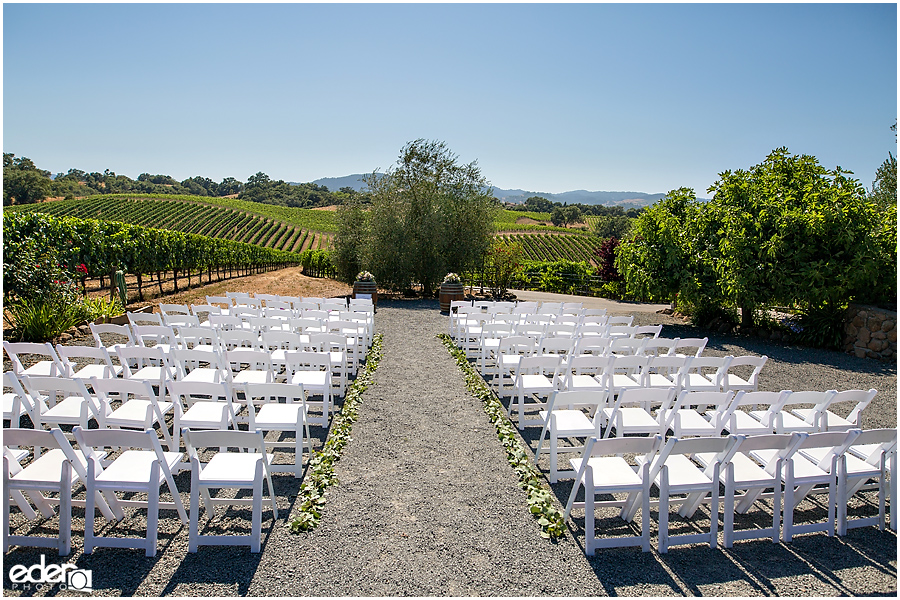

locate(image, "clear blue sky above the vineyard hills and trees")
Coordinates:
3 4 897 196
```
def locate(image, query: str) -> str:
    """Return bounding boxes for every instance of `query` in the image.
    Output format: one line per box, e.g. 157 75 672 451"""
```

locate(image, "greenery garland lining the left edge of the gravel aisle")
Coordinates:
290 333 382 533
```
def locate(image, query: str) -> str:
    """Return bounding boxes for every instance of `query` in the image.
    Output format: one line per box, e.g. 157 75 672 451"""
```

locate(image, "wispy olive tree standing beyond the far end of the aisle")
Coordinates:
356 139 499 295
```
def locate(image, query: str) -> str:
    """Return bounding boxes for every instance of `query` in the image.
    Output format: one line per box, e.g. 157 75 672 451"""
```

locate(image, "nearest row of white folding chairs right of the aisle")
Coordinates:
565 430 896 554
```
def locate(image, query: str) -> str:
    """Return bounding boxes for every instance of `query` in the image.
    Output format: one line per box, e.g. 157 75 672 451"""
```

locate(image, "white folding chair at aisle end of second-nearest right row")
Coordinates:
534 390 607 483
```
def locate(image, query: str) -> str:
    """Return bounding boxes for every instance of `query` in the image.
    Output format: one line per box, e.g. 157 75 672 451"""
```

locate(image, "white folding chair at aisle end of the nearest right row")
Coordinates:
564 435 662 555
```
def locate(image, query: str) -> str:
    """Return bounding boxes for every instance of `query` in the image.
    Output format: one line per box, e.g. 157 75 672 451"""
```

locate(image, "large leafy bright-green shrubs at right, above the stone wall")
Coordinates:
616 148 897 339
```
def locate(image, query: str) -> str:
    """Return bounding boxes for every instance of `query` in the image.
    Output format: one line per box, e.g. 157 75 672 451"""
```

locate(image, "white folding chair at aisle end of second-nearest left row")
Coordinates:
241 383 312 479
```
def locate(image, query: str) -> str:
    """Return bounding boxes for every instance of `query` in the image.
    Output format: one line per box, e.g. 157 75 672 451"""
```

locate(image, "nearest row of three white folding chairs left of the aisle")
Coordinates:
3 427 278 557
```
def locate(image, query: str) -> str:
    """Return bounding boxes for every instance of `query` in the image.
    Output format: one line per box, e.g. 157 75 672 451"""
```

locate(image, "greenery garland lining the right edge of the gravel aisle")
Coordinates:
437 333 566 538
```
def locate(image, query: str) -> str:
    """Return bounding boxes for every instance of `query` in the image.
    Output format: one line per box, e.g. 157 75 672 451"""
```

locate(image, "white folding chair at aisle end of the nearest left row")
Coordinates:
182 429 278 553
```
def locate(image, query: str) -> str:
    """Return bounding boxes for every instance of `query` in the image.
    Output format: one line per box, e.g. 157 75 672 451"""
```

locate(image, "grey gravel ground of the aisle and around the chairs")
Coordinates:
4 294 897 597
